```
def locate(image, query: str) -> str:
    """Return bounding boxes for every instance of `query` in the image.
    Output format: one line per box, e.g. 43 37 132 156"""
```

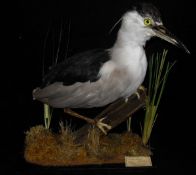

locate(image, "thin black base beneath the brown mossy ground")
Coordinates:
19 163 156 175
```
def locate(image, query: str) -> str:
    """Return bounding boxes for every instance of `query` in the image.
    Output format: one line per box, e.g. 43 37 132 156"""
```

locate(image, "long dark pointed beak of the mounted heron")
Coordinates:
152 25 190 54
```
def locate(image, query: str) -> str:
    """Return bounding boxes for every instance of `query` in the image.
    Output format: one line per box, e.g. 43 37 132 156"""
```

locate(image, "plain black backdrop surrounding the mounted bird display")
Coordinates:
0 0 196 174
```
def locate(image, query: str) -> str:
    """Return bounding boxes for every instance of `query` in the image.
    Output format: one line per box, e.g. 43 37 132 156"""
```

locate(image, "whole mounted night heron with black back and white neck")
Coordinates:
33 4 189 132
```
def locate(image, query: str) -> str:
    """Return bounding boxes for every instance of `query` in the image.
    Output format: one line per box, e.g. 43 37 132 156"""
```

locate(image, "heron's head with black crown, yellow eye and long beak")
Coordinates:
121 3 190 53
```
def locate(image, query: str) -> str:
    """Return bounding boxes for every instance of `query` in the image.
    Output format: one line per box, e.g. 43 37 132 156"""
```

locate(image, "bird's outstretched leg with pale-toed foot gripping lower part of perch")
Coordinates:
64 108 111 134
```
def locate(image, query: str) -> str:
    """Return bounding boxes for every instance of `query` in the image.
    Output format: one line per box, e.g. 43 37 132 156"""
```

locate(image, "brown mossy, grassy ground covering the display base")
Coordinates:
24 124 152 166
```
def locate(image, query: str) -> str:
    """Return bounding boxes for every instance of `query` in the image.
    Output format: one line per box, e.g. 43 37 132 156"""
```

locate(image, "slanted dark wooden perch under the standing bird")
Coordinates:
76 90 146 143
